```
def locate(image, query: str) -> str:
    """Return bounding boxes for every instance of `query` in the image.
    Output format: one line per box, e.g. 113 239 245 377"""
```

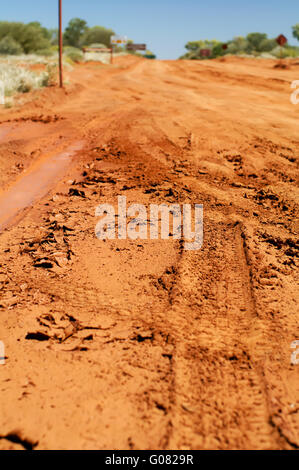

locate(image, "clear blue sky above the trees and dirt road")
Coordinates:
0 0 299 59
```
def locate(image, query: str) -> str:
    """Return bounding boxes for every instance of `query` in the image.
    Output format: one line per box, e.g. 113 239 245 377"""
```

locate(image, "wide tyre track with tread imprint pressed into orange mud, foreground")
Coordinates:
143 223 278 449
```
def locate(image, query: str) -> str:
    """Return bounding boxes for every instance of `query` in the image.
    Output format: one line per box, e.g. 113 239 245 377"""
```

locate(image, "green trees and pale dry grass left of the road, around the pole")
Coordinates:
0 18 155 105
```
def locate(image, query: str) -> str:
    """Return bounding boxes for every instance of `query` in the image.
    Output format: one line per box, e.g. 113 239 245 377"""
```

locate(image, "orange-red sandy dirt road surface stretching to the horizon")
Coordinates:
0 56 299 449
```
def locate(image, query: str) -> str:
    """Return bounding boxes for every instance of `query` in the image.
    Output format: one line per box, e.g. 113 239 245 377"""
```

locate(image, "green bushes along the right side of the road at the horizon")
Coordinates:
180 23 299 60
